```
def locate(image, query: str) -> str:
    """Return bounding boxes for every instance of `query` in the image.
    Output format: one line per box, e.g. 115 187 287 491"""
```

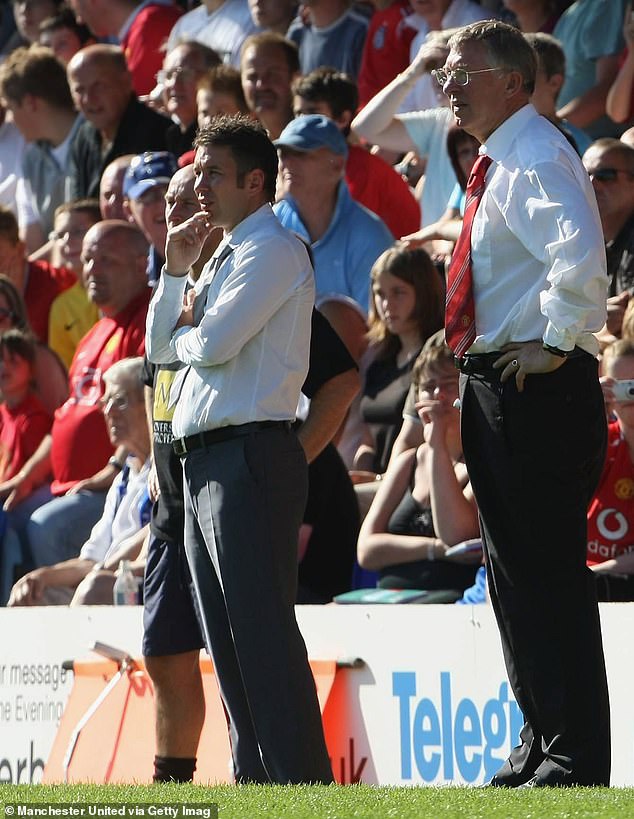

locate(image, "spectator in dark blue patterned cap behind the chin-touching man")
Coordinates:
123 151 178 285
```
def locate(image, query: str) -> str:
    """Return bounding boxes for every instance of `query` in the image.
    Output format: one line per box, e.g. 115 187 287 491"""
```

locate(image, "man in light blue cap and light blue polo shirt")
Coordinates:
274 114 394 315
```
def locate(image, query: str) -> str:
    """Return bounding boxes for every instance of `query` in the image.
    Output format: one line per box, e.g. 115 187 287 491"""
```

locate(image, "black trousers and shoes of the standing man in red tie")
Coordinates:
460 354 610 785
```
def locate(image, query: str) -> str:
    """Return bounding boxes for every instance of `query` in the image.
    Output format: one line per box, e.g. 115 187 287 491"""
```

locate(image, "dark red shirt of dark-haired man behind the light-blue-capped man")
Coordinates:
346 145 420 239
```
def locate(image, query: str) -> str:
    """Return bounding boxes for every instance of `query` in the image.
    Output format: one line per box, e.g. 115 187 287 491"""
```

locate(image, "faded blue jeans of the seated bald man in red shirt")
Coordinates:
26 491 106 568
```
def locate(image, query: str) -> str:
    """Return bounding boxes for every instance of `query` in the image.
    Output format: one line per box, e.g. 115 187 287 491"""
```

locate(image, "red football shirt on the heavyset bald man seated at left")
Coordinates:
51 287 152 495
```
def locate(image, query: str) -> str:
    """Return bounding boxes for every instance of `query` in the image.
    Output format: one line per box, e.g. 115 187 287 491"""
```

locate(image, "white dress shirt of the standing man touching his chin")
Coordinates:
146 205 315 438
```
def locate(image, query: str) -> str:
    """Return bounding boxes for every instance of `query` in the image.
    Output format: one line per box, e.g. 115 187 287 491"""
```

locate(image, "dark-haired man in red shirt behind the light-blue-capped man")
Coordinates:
292 68 420 239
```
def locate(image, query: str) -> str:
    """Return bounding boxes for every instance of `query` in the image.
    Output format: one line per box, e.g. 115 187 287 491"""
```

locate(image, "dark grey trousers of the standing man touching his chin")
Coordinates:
184 428 332 784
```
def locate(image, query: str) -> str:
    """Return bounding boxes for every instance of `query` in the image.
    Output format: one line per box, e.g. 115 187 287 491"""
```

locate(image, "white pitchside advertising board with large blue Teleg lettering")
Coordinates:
0 604 634 785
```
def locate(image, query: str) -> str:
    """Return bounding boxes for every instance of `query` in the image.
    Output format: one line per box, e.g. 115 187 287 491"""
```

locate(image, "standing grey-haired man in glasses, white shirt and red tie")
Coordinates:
436 21 610 787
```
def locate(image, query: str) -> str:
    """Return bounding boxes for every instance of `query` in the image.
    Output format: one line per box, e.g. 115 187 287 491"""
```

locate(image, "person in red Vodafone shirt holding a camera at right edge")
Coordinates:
587 339 634 601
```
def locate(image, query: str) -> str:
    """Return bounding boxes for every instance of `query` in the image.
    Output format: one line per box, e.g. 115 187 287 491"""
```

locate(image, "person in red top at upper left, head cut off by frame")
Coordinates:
70 0 182 96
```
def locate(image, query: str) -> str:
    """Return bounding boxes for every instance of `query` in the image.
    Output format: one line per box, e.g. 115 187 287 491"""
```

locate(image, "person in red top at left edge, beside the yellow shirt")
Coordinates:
0 206 77 344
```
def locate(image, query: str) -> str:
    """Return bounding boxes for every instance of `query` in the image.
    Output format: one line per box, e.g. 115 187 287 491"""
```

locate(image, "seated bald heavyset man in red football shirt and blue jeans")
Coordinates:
0 220 151 566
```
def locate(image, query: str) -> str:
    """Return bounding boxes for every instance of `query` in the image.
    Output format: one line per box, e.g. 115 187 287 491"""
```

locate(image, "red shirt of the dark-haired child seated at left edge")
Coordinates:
0 392 53 481
